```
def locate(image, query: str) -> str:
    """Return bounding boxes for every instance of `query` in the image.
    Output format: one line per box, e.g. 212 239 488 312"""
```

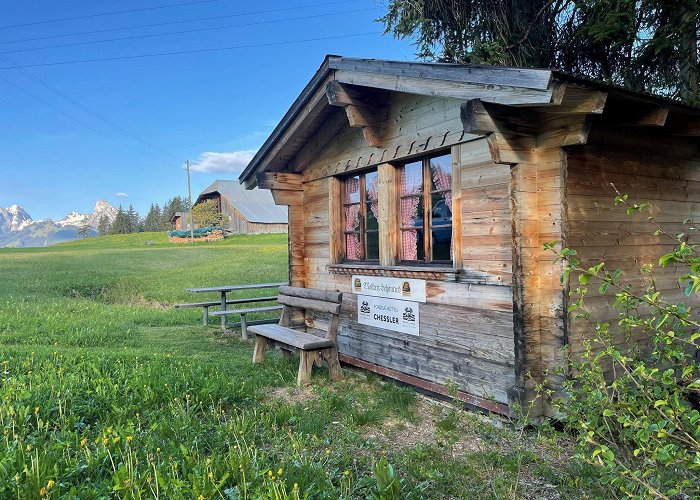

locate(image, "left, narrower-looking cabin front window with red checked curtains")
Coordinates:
343 170 379 261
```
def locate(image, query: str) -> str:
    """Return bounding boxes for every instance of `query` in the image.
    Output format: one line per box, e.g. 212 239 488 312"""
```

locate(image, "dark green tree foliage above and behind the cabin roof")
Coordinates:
380 0 700 103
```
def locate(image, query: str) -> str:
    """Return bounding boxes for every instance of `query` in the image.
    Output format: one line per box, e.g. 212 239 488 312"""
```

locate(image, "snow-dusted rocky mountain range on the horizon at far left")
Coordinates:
0 200 117 247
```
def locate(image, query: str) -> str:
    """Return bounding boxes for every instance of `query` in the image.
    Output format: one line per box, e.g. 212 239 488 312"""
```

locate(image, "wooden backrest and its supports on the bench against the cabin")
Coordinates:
277 285 343 342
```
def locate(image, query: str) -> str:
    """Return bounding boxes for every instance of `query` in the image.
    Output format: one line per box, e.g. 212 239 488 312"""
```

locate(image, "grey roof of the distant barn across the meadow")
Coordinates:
195 180 287 224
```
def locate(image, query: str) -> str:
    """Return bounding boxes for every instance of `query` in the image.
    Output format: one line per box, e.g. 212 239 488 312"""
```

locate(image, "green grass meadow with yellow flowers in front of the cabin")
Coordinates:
0 233 611 499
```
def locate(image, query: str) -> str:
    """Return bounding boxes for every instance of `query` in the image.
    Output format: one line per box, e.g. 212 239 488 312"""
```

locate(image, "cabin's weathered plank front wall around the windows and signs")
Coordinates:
289 93 517 411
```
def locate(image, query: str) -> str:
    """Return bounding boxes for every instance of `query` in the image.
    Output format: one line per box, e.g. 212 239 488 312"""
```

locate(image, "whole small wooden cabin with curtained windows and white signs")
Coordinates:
240 56 700 415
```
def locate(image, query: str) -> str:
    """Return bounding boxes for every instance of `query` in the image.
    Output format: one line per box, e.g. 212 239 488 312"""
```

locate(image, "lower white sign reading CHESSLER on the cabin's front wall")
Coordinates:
357 295 420 335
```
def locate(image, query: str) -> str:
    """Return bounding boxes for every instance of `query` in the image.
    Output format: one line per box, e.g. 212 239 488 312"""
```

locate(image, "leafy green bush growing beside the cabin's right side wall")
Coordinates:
545 193 700 498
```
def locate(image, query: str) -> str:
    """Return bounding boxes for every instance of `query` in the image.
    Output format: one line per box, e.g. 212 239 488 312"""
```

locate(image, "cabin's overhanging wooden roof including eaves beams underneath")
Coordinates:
239 55 700 189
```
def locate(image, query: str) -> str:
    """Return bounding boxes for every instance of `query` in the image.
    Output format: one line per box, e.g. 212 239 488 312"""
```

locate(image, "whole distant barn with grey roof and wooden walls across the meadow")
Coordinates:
195 180 287 234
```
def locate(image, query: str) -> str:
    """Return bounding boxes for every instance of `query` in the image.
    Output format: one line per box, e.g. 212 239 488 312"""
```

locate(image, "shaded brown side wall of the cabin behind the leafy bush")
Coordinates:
565 125 700 372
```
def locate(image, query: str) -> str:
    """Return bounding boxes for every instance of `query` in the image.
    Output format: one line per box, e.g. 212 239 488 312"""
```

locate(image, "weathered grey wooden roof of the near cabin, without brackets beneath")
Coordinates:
239 55 700 189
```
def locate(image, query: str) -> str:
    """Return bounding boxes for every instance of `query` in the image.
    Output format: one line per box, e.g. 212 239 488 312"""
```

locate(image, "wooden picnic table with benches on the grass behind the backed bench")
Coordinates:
174 283 286 338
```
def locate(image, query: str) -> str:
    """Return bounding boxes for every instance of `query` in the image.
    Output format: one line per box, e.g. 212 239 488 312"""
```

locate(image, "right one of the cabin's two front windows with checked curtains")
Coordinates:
399 154 452 263
